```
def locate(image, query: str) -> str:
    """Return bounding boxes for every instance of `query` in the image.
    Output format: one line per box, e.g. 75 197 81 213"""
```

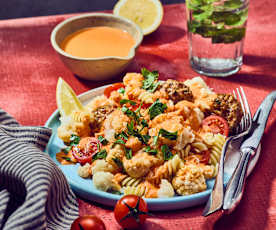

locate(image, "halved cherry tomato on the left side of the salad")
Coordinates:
72 137 102 165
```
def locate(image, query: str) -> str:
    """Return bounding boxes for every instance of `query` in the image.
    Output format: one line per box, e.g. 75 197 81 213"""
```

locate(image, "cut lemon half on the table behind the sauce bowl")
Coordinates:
113 0 163 35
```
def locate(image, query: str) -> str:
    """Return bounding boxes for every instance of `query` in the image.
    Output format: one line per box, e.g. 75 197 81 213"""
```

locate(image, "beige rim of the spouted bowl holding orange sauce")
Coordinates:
50 13 144 61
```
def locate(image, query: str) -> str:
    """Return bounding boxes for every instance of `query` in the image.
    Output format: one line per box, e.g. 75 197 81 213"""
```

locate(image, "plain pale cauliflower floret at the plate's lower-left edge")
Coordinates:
93 172 114 192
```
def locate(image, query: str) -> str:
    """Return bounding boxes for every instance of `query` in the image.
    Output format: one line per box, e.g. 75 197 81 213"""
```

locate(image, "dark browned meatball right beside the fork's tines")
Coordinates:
211 94 243 133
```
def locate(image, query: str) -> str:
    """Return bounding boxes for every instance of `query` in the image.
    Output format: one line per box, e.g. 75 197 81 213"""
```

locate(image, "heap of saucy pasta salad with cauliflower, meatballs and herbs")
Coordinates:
56 68 242 198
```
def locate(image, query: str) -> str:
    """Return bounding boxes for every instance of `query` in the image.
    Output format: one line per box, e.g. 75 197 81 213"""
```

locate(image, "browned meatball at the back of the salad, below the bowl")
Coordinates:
160 79 194 104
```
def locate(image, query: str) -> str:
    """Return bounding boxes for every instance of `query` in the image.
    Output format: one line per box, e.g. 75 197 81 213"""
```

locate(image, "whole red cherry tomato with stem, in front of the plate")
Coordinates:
114 195 150 229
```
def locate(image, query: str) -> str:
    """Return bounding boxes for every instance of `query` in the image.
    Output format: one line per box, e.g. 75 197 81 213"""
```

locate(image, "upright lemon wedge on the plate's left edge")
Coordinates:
56 77 84 117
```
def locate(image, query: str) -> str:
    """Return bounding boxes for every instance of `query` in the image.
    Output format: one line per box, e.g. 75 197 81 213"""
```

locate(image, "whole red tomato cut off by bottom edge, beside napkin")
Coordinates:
71 215 106 230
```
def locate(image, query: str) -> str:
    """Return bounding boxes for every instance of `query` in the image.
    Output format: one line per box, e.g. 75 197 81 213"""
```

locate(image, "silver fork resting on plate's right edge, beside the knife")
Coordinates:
202 87 252 216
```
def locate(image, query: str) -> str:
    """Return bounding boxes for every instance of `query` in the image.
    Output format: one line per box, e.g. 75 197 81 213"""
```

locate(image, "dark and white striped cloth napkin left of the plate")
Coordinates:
0 109 79 230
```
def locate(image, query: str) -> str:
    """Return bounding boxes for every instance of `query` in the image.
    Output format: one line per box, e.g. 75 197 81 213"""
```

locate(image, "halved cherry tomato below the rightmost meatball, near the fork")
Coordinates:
202 115 229 136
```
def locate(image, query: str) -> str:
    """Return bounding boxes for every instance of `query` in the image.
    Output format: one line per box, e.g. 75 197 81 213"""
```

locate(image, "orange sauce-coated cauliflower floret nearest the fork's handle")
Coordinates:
172 164 207 195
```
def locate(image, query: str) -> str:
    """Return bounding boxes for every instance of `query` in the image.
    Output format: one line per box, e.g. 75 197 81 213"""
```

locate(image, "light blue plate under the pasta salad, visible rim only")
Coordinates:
45 86 260 211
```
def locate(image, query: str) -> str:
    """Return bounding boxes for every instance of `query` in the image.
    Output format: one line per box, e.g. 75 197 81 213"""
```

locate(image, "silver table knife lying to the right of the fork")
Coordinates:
223 90 276 213
